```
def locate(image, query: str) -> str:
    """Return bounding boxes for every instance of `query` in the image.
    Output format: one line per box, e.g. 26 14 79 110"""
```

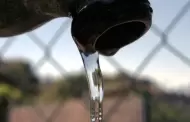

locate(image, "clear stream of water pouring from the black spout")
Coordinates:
80 52 103 122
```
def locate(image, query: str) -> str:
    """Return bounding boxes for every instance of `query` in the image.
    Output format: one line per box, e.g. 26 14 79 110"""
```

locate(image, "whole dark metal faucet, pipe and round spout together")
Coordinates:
0 0 153 56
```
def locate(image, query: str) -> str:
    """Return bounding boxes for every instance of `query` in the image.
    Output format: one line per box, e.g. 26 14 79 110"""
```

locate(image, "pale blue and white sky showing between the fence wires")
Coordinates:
0 0 190 89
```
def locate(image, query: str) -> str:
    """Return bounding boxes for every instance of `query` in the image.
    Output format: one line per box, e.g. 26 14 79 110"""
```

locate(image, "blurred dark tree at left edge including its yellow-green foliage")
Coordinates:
0 60 38 122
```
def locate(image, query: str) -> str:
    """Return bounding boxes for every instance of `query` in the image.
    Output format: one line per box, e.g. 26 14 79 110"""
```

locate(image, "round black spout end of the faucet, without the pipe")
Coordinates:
71 0 153 56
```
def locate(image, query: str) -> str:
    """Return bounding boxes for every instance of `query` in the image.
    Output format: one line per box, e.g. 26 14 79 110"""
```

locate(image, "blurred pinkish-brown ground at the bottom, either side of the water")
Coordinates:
10 96 142 122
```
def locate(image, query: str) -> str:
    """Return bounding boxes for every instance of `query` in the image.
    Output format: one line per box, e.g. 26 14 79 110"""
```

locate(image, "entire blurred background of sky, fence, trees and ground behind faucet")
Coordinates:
0 0 190 122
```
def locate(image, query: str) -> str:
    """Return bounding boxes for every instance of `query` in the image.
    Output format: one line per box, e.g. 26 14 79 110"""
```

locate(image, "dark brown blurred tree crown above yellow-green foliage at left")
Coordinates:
0 60 39 102
